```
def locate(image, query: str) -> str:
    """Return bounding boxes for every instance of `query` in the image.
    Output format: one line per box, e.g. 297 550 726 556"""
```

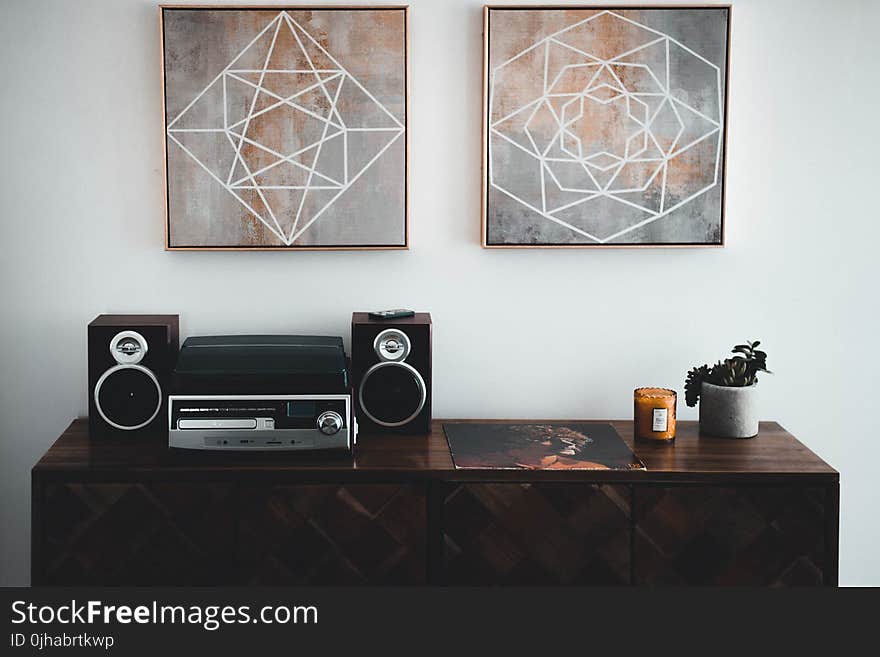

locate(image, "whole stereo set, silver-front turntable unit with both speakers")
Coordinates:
88 311 431 452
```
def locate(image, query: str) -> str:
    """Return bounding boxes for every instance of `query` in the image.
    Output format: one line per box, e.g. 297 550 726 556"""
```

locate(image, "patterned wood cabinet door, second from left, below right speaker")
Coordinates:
238 484 427 586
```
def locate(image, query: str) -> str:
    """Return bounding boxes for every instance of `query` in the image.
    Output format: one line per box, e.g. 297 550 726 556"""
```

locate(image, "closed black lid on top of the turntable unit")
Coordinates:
175 335 348 394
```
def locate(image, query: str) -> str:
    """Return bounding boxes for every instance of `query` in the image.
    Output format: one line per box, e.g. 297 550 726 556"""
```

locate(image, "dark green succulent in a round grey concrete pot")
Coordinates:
684 340 770 438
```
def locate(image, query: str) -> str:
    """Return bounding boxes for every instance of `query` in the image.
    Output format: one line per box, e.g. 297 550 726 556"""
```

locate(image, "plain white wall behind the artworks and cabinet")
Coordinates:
0 0 880 585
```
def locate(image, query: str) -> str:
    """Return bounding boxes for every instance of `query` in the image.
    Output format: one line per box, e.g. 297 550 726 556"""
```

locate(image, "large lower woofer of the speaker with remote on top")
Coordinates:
358 361 427 427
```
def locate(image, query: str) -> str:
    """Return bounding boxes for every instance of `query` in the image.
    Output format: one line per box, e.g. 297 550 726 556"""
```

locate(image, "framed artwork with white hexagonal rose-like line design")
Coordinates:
482 6 730 247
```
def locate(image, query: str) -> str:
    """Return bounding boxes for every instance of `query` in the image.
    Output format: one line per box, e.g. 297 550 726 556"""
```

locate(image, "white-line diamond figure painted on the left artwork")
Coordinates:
167 11 405 246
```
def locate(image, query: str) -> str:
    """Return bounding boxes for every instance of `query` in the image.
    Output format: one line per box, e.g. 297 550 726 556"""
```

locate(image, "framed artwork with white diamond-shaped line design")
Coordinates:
160 5 409 250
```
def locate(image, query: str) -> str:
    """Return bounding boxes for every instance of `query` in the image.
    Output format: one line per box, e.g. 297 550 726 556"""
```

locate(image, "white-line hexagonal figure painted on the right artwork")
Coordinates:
489 11 724 243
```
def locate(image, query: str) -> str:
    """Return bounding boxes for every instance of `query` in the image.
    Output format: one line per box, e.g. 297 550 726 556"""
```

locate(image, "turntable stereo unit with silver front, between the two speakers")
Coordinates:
167 335 357 451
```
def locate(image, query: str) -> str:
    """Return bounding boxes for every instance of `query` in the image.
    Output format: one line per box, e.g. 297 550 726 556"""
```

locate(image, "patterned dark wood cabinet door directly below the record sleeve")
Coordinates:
443 483 631 585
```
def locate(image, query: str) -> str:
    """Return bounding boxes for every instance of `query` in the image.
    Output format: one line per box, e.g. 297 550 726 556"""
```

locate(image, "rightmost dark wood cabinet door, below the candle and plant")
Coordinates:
633 486 827 586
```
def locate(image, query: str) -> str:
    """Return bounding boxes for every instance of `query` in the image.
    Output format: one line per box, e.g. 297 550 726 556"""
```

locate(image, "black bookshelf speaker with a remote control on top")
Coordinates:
351 313 431 434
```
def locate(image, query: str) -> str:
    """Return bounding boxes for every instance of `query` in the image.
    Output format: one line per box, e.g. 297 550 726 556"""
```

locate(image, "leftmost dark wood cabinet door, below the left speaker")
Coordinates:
35 482 234 586
